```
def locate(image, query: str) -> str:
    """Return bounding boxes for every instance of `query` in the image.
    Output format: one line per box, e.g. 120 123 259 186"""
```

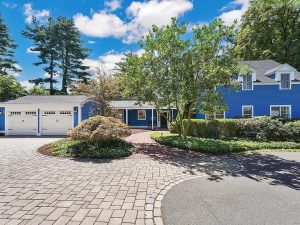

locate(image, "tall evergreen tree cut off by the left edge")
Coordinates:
0 14 20 75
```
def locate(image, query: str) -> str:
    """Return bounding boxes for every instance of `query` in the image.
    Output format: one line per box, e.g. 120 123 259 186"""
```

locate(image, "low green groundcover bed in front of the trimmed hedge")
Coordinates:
151 132 300 154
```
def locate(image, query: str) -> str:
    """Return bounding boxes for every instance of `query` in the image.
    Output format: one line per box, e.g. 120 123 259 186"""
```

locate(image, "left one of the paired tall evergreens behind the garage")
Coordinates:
23 18 58 95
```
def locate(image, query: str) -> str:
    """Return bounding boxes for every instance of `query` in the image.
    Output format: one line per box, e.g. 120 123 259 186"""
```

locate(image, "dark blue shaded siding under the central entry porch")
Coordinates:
128 109 157 126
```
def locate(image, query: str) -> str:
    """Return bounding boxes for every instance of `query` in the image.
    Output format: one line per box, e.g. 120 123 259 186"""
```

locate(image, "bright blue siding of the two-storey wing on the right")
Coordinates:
197 84 300 119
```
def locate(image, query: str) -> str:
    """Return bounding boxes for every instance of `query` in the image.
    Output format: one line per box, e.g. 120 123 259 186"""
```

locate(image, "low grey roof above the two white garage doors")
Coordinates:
4 95 88 104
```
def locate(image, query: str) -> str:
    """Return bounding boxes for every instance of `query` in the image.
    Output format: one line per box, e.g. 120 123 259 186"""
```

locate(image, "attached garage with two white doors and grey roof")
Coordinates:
0 95 95 136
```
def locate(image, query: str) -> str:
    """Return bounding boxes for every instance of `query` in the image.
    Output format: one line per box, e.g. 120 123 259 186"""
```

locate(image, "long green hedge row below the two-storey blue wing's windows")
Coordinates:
170 117 300 142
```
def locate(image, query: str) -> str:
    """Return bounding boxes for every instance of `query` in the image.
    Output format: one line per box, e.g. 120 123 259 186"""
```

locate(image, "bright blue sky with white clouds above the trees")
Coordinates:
0 0 249 89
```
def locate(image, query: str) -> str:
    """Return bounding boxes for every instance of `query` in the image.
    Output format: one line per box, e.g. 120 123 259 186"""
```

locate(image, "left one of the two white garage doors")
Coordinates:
7 111 38 135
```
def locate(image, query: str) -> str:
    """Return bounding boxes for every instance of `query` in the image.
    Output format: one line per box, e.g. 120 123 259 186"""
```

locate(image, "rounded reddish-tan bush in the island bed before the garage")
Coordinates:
68 116 131 140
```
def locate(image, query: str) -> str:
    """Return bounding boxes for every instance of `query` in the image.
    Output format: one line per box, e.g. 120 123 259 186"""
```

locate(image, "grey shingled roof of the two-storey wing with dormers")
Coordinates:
240 60 300 83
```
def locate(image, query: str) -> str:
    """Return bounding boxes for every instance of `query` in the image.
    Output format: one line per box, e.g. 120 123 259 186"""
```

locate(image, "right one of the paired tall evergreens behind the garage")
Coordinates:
56 17 90 94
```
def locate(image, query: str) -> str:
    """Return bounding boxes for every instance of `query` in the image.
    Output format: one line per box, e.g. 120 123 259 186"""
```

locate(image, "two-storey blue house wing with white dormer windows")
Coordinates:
196 60 300 119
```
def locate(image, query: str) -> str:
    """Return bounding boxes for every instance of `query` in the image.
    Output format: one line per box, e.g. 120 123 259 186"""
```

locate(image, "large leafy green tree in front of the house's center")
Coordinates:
118 19 243 134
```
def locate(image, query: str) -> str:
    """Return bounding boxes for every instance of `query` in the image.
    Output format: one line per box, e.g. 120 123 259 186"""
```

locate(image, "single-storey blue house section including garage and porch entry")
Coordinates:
0 95 176 136
